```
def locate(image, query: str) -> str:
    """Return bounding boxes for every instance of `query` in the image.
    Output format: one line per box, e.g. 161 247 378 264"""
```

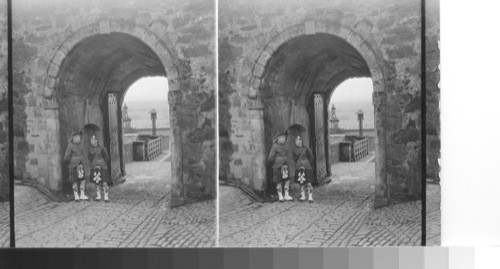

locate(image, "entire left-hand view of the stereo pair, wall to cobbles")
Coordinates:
10 0 217 247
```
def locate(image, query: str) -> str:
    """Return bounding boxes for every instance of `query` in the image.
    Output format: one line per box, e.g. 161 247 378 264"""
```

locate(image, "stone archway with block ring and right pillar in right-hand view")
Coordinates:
249 20 388 207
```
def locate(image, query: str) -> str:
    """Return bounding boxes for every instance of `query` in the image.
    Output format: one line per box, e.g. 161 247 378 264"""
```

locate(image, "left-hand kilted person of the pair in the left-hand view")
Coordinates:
64 133 89 202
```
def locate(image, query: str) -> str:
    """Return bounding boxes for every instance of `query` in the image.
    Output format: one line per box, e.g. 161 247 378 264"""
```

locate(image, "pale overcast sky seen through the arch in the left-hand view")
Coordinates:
124 77 168 103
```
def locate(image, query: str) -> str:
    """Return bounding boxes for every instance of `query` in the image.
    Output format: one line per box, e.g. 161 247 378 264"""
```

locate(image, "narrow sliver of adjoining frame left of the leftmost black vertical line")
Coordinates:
0 1 10 248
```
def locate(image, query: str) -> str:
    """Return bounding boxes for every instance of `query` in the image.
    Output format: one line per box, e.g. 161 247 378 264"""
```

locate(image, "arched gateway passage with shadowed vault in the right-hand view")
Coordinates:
251 23 387 206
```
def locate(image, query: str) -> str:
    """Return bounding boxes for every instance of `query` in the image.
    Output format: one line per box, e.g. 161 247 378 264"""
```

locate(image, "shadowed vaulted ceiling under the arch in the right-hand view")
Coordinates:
262 34 370 101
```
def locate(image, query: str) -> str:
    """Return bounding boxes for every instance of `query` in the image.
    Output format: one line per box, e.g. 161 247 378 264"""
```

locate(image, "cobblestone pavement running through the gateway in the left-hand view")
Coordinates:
15 154 216 247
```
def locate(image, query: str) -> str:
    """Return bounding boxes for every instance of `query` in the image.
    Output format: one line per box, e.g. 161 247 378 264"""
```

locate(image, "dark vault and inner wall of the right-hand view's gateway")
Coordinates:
260 33 371 192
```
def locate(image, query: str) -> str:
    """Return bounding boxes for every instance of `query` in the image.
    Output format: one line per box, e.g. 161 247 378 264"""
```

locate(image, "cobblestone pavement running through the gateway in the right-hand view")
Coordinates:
219 162 421 247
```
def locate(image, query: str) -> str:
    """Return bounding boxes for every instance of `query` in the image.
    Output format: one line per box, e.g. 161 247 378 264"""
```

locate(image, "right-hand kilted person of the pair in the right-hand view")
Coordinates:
293 136 314 203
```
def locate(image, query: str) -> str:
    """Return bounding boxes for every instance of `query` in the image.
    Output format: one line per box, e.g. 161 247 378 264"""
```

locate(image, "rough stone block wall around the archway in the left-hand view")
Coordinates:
13 0 215 204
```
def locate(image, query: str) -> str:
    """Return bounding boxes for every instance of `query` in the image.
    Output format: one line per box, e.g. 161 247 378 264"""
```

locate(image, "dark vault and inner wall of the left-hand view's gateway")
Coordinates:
55 33 166 193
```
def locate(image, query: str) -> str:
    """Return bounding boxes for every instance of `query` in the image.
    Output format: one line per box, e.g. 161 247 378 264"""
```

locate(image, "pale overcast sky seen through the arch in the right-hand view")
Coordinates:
330 78 373 106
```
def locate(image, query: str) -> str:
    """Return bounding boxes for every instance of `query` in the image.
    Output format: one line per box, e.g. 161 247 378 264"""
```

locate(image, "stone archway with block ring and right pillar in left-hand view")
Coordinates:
44 20 185 206
